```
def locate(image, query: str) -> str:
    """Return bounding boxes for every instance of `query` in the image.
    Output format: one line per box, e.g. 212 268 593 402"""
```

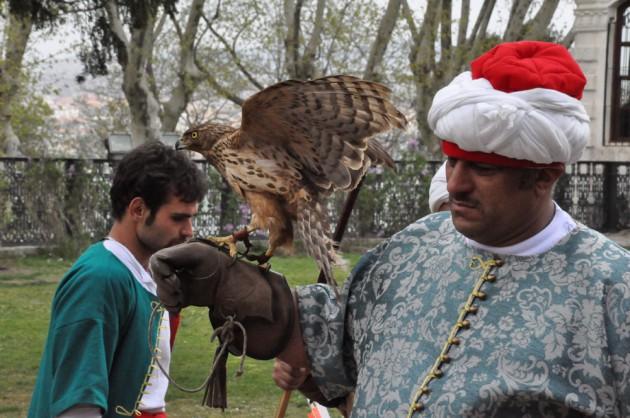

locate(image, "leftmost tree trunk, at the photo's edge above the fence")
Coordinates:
0 6 33 157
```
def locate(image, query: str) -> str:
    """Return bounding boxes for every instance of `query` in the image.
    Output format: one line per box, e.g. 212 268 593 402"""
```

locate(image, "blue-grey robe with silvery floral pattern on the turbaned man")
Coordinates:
298 212 630 418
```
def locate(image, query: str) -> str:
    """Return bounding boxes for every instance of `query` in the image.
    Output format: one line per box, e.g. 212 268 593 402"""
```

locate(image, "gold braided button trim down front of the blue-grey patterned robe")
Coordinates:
407 256 503 418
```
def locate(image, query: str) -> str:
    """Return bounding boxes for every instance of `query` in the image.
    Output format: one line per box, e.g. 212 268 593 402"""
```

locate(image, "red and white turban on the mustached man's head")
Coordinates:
428 41 590 167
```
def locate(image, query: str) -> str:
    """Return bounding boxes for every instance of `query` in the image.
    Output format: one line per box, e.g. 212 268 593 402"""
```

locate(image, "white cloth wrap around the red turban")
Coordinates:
428 71 590 164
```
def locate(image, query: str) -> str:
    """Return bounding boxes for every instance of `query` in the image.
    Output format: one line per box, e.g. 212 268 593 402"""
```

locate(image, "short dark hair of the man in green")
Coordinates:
109 141 208 220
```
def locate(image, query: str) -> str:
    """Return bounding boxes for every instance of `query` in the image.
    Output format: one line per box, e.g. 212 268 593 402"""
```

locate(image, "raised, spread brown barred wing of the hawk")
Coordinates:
240 75 407 189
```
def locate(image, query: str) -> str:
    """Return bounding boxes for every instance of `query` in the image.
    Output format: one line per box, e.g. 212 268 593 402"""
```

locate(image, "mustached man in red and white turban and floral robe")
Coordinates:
149 41 630 418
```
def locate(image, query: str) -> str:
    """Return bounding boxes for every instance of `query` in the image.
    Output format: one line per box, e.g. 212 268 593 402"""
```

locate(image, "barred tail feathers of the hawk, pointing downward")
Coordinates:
297 195 346 291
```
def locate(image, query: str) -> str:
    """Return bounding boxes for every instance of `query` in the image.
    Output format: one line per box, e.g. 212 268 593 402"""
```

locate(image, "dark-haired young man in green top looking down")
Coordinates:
28 143 207 418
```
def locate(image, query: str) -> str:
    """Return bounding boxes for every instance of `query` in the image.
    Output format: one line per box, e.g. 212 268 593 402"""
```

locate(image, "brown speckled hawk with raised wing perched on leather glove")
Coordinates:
177 75 407 283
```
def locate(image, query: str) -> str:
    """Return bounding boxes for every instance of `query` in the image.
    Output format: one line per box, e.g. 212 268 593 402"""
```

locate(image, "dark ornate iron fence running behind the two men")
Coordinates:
0 158 630 246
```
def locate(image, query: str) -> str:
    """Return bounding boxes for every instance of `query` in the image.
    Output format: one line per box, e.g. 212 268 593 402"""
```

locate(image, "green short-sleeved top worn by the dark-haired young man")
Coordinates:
28 242 160 418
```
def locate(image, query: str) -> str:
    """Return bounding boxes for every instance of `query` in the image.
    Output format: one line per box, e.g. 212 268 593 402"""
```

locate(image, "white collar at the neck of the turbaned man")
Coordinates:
464 202 577 256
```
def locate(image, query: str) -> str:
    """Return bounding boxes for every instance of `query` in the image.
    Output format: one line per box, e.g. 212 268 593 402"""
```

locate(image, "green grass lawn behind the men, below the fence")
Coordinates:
0 254 359 418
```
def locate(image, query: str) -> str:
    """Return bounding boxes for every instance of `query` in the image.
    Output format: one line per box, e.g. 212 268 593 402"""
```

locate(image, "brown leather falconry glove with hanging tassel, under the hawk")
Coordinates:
149 241 297 408
